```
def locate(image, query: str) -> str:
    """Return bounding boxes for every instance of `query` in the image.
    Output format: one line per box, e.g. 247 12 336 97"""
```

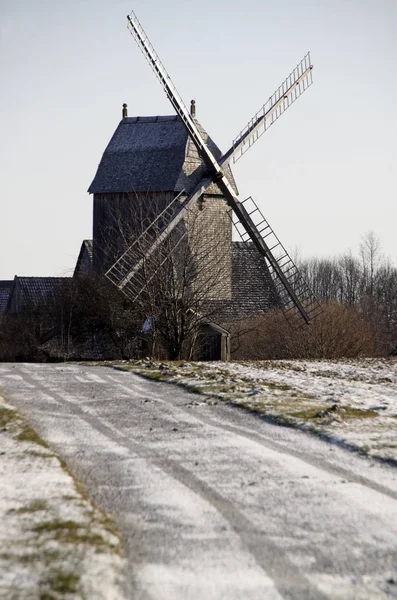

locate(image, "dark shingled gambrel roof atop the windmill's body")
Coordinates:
88 115 237 194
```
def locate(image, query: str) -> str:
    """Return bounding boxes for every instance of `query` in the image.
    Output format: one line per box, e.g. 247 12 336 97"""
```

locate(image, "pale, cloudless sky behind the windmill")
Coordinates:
0 0 397 279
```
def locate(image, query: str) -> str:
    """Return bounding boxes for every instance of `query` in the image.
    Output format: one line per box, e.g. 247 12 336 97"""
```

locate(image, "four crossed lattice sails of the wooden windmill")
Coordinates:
106 12 320 323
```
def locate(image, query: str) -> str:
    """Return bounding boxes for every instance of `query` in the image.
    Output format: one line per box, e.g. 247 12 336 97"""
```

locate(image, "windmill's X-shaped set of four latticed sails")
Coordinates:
105 12 321 327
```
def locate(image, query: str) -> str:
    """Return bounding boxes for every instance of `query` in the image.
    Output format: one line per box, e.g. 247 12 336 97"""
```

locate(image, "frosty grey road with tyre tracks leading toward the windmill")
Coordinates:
0 364 397 600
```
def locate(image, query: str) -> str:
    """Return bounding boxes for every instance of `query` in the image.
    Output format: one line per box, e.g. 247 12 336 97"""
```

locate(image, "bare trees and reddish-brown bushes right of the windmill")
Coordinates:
234 231 397 359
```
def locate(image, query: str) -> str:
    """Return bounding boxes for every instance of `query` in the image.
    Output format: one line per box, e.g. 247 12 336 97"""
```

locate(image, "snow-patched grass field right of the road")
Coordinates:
119 358 397 464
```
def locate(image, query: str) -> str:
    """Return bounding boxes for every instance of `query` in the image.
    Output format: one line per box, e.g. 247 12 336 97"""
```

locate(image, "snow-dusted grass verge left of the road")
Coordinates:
0 396 125 600
